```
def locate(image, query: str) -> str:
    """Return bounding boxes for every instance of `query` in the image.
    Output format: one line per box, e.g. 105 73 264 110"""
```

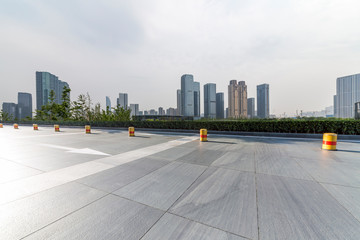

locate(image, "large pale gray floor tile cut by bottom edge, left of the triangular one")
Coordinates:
25 195 163 240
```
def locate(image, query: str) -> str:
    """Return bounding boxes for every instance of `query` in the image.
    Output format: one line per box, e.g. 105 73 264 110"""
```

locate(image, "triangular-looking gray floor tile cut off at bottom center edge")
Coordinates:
142 213 245 240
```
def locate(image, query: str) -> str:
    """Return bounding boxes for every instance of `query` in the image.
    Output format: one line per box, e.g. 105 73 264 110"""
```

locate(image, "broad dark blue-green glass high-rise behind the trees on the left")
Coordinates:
36 72 69 110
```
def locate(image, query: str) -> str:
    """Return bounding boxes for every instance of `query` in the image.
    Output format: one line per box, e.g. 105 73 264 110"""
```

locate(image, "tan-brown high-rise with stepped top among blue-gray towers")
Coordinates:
228 80 247 118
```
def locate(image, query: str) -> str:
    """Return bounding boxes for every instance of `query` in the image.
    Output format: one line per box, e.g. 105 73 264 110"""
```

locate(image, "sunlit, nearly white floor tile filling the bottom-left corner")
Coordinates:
0 183 106 240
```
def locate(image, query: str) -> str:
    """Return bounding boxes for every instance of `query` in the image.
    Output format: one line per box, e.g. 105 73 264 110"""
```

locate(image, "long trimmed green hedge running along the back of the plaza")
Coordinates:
18 119 360 135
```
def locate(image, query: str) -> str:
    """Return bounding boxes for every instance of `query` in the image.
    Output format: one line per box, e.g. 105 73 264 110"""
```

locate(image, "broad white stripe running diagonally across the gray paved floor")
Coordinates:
0 137 197 204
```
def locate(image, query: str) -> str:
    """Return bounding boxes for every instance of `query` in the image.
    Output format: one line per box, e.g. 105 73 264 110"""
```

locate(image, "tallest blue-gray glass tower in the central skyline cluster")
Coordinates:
181 74 194 116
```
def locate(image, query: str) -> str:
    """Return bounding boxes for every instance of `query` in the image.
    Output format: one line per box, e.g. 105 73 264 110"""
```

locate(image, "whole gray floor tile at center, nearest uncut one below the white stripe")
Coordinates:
114 162 206 210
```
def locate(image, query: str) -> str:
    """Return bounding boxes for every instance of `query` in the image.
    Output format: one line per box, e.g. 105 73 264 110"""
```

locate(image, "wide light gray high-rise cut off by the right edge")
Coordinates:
334 74 360 118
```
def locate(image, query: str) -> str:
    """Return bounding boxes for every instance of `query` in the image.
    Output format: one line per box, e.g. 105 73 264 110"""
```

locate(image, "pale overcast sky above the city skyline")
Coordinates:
0 0 360 115
